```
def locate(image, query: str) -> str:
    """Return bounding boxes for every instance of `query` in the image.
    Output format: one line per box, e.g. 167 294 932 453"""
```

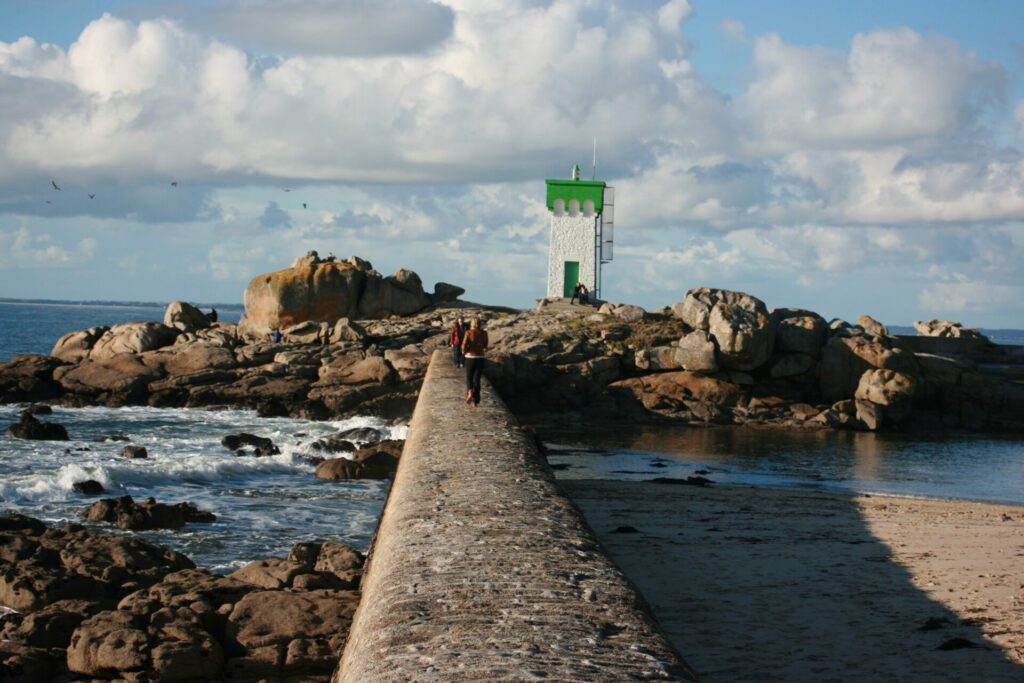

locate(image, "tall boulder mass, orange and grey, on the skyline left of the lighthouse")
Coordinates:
242 252 462 338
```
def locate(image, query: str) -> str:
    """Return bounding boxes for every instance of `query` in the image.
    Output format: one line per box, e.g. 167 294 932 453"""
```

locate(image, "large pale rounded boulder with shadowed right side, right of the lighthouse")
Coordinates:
708 297 775 372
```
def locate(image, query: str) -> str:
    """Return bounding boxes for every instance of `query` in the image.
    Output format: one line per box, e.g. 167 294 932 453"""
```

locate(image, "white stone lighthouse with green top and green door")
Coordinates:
547 166 614 298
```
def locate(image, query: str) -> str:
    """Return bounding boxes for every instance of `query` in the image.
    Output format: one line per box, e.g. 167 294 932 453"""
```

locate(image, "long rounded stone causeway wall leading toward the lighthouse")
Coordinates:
334 351 693 683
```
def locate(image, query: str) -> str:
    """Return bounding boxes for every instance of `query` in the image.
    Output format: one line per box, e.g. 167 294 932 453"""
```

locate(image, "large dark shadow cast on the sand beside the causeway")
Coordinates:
561 428 1024 682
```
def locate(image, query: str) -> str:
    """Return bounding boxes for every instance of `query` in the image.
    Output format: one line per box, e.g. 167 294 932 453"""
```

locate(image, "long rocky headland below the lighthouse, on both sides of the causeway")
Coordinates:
0 266 1024 432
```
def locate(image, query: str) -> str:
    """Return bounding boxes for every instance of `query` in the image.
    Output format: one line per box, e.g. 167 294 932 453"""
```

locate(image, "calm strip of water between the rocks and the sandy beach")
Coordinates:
540 426 1024 505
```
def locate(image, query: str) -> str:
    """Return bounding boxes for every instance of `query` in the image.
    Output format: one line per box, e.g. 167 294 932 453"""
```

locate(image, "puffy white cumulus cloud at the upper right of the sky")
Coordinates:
740 29 1006 148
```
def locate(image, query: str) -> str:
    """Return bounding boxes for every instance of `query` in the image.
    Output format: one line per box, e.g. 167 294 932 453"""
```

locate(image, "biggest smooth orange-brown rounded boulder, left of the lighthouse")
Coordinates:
245 253 367 336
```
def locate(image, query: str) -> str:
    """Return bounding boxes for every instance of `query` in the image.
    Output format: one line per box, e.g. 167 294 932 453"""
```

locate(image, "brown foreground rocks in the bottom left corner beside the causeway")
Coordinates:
0 515 362 683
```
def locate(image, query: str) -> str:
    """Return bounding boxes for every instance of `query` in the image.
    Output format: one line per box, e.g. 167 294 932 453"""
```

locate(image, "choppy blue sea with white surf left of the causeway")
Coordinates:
0 302 391 571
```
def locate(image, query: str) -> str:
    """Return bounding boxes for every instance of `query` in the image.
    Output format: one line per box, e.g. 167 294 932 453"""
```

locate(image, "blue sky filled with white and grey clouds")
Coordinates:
0 0 1024 328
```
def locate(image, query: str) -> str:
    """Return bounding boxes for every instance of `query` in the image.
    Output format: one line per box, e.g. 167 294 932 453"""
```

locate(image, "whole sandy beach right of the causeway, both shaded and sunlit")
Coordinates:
560 480 1024 682
